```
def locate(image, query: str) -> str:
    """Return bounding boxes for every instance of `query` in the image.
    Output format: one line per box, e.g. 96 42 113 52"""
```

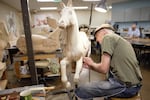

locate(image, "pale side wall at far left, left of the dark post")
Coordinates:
0 2 22 45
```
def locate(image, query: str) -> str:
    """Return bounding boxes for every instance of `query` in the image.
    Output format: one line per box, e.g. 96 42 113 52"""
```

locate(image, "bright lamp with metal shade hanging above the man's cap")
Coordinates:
95 0 107 13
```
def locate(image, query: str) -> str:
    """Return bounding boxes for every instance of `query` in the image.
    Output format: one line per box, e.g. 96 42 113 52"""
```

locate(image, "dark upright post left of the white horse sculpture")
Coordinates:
21 0 38 84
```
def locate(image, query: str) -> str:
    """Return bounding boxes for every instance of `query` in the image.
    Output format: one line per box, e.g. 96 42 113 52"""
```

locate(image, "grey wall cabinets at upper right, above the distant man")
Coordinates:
112 7 150 22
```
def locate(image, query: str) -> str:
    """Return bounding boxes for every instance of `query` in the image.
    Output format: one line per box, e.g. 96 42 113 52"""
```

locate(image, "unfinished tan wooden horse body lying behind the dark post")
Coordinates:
16 18 60 54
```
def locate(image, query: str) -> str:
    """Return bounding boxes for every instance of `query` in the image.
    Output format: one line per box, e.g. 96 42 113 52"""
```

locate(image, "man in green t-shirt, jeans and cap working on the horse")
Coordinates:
75 24 142 100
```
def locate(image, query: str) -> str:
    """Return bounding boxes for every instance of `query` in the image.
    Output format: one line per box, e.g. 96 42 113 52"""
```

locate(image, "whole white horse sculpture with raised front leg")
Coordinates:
58 0 91 88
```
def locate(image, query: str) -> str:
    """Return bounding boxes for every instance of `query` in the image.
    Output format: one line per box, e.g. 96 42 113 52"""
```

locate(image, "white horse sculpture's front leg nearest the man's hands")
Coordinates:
74 57 83 83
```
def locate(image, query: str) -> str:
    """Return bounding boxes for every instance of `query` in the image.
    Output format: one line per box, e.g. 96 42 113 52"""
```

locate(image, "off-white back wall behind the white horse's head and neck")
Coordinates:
32 10 111 26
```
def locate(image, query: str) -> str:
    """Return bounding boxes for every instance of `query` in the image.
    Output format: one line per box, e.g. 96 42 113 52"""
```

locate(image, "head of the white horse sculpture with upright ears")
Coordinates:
58 0 77 29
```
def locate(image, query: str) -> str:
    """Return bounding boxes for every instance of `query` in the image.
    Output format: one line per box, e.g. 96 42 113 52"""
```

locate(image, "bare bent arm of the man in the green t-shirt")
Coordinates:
83 53 111 74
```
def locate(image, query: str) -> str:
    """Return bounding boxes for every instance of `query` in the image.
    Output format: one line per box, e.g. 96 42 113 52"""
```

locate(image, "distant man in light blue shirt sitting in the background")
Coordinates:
128 24 140 38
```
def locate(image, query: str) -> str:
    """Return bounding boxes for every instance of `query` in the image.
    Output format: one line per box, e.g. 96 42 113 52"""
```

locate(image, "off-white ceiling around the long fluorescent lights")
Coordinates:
1 0 129 11
